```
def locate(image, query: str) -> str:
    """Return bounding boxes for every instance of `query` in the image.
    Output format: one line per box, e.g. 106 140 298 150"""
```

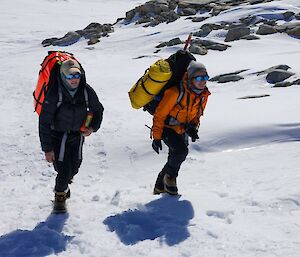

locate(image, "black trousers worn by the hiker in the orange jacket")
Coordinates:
160 128 189 178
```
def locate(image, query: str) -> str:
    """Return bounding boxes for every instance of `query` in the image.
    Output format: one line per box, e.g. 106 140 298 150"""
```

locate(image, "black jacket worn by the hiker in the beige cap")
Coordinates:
39 70 104 152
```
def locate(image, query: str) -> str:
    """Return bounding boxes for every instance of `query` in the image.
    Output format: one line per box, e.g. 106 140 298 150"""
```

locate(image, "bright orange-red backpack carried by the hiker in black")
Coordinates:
33 51 77 115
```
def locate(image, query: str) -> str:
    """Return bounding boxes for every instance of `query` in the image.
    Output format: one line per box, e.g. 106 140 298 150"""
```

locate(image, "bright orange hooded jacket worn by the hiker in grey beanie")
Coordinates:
152 74 210 139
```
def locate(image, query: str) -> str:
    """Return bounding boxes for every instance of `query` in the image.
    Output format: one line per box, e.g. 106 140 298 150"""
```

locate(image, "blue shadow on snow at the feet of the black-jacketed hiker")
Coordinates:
0 214 73 257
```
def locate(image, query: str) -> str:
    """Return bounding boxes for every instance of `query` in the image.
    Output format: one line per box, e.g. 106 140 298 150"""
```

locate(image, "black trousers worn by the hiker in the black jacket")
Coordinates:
52 132 84 192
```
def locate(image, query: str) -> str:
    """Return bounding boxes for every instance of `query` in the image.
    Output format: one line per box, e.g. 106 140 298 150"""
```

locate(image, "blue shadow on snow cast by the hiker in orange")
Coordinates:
103 196 194 246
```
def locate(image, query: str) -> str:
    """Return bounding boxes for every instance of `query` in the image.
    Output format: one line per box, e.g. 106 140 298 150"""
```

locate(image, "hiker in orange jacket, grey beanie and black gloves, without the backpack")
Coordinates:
152 61 210 195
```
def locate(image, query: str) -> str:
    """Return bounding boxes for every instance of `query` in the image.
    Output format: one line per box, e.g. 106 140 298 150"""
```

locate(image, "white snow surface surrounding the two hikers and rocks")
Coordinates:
0 0 300 257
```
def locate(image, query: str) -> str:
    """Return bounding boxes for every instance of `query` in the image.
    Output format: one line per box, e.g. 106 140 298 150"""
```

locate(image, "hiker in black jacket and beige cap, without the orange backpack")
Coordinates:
39 59 104 212
